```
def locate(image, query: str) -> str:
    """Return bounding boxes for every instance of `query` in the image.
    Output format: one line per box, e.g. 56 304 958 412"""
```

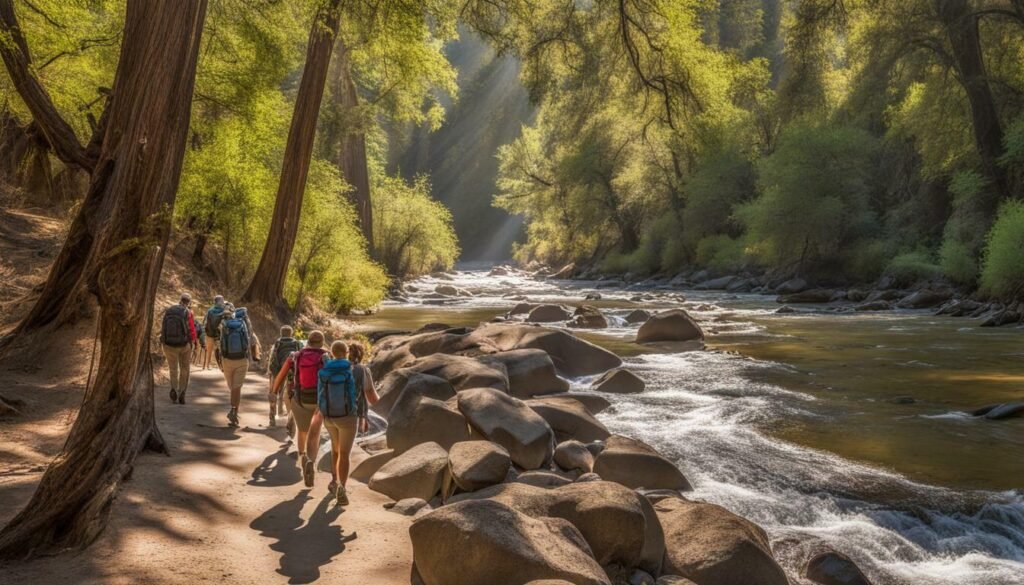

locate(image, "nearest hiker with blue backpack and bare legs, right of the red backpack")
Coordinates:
316 341 380 506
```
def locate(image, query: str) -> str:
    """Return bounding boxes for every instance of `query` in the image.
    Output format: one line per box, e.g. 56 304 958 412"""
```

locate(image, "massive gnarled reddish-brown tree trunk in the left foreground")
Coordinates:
0 0 206 558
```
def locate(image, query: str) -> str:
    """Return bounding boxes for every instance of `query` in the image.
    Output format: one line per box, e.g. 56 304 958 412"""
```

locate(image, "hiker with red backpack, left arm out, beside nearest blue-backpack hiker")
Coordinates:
270 331 327 488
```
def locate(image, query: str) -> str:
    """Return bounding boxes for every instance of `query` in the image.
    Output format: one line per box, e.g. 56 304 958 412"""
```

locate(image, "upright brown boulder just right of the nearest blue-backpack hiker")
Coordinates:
386 388 469 454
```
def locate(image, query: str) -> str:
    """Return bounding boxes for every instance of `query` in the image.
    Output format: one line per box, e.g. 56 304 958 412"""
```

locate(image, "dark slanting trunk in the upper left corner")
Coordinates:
0 0 95 170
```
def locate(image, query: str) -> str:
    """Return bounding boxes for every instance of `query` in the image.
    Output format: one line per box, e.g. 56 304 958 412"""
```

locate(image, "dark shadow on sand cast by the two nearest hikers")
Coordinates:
249 490 356 583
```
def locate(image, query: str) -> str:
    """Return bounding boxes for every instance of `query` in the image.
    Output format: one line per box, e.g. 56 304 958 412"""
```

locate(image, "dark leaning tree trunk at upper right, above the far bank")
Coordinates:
935 0 1010 211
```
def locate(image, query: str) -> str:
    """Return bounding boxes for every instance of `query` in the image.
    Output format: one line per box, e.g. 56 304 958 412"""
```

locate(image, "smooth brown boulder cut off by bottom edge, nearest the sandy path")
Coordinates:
409 500 610 585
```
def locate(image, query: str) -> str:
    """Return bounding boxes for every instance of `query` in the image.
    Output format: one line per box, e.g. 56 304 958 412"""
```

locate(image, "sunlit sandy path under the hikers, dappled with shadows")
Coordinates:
0 370 412 585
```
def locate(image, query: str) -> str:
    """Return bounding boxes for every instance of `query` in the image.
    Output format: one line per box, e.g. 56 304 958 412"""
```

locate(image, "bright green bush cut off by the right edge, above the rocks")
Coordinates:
981 201 1024 298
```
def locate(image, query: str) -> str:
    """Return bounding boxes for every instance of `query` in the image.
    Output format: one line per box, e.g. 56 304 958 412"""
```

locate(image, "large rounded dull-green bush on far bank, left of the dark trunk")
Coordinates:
736 125 878 270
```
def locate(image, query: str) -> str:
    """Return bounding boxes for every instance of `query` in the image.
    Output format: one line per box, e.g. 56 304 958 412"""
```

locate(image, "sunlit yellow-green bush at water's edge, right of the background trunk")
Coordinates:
373 176 459 278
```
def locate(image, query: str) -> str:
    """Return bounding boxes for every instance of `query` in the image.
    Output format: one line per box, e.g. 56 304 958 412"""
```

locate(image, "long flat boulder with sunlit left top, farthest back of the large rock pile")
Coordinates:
466 323 623 378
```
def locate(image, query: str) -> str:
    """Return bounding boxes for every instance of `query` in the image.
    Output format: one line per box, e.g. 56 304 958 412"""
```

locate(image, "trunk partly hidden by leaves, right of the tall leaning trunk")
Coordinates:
333 43 374 247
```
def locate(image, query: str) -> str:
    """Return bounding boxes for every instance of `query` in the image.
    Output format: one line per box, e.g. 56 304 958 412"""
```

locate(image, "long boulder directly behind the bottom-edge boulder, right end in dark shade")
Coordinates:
455 482 665 568
